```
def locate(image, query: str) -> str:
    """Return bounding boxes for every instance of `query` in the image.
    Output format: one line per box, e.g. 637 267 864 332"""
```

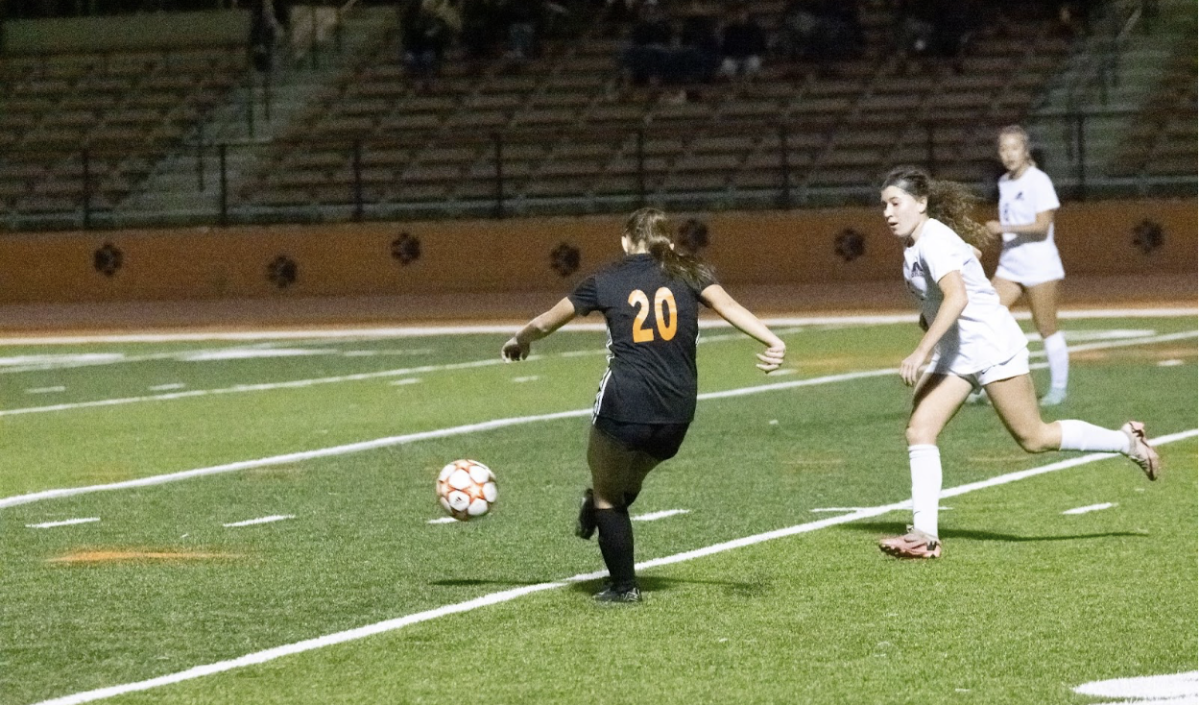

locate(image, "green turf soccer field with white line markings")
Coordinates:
0 312 1198 705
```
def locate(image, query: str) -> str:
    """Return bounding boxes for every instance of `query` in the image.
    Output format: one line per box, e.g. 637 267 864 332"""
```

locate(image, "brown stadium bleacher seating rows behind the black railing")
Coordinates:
0 0 1195 228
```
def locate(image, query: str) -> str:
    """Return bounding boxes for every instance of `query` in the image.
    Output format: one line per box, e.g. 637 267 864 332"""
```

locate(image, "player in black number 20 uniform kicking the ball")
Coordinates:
502 209 787 602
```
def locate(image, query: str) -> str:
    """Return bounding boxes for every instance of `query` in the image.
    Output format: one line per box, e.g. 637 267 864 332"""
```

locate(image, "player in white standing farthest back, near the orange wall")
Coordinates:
988 125 1068 406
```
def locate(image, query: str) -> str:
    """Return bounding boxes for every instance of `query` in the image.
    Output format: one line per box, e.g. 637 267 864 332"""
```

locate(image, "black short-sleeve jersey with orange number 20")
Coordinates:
570 254 715 423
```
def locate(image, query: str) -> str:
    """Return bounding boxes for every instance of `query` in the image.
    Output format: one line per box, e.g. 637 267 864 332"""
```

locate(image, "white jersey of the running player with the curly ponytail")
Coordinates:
904 218 1026 375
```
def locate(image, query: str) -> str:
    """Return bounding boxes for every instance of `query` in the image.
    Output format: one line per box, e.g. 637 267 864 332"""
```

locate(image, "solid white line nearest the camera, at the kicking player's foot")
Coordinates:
35 429 1200 705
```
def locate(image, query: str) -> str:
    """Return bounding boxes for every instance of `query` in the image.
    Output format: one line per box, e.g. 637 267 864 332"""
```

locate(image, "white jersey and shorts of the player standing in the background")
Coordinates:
996 167 1066 287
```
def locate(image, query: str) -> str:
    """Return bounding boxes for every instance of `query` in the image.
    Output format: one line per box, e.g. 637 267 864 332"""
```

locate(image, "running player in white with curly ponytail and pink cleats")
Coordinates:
880 167 1159 558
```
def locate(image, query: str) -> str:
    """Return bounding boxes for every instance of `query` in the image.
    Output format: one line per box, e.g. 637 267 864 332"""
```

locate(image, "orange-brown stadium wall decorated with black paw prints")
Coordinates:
0 199 1198 303
